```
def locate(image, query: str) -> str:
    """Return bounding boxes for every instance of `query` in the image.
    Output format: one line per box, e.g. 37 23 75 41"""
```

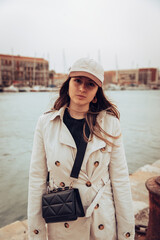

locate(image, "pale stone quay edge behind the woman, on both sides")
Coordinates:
0 160 160 240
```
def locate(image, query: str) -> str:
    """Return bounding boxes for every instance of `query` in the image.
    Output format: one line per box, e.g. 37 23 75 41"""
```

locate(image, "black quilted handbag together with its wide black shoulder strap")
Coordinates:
42 124 89 223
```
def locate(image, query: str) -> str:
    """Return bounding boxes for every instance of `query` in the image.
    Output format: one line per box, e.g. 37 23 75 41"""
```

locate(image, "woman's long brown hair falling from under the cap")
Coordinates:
52 78 120 146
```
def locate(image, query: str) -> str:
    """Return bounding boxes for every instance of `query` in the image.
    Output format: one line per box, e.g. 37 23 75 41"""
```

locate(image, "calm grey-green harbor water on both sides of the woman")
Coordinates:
0 90 160 227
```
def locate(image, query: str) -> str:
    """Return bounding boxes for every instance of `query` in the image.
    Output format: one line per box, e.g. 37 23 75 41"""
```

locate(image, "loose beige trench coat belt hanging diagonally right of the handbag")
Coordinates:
85 178 109 217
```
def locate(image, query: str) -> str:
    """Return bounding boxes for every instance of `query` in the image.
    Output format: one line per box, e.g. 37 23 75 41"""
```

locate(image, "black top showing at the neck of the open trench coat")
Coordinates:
63 108 85 149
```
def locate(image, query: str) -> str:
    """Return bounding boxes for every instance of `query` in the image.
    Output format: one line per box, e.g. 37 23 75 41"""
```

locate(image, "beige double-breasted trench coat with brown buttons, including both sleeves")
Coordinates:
28 107 134 240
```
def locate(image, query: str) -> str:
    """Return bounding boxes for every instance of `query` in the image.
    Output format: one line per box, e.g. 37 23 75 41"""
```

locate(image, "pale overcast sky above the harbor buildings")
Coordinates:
0 0 160 72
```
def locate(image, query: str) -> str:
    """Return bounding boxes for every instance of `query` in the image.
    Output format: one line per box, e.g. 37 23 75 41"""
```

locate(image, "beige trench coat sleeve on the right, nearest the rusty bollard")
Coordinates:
109 119 135 240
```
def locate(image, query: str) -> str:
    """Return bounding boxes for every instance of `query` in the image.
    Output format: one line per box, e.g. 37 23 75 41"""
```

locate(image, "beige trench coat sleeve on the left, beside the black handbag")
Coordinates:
28 117 47 240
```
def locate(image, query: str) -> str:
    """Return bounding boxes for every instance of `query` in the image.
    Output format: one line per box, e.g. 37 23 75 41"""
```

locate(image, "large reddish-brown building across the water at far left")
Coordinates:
0 54 49 87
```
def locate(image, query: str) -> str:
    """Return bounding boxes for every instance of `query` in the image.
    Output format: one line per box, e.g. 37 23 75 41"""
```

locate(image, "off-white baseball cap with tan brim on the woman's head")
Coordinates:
69 58 104 87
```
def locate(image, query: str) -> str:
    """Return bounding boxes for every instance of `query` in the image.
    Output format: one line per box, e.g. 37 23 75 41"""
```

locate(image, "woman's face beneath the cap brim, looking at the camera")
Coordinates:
69 77 98 108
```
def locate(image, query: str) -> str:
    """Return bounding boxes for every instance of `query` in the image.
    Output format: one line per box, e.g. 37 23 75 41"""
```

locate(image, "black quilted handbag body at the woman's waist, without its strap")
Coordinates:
42 187 85 223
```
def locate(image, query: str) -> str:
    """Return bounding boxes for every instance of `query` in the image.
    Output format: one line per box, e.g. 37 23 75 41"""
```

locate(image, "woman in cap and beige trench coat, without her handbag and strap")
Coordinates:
28 58 134 240
